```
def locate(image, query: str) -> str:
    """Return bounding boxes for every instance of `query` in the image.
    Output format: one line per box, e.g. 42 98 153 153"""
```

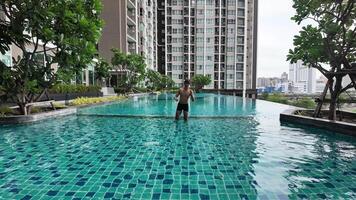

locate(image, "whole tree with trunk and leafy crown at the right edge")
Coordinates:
287 0 356 120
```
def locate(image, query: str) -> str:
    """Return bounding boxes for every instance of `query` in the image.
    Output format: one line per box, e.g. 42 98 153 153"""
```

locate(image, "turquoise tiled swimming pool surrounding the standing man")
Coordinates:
0 94 356 199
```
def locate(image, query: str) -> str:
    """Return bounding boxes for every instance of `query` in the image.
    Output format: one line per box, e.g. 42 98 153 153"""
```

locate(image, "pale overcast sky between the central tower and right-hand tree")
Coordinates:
257 0 300 77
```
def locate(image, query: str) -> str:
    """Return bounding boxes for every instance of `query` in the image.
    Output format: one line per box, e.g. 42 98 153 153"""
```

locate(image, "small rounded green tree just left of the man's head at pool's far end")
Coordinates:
146 70 174 90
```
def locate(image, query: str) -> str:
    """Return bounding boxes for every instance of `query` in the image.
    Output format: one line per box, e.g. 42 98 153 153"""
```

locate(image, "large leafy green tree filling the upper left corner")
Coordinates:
0 0 102 115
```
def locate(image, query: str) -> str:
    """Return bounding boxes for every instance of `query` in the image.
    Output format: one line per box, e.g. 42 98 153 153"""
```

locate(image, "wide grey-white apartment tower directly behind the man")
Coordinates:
157 0 258 96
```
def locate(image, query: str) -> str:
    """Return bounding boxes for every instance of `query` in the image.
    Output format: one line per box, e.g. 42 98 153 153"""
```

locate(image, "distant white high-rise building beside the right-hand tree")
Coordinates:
289 60 316 93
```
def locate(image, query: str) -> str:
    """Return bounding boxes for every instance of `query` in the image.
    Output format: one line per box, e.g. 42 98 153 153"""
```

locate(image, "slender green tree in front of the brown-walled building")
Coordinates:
111 49 146 91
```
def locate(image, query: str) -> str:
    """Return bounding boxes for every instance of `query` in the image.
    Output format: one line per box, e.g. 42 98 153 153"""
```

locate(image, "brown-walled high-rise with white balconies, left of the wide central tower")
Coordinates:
98 0 157 70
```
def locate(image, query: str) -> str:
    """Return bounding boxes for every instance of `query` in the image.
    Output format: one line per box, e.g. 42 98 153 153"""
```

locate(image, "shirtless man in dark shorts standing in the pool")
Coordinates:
175 80 195 120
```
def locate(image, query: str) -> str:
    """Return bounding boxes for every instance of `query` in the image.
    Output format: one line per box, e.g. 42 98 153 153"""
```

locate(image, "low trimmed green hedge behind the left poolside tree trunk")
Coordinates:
49 84 101 94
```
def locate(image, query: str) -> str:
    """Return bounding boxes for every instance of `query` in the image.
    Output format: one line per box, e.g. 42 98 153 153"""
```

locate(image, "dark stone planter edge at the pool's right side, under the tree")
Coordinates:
279 108 356 137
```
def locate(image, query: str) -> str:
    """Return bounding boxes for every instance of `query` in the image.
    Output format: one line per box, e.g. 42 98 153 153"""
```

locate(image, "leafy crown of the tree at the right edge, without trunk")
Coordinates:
287 0 356 67
